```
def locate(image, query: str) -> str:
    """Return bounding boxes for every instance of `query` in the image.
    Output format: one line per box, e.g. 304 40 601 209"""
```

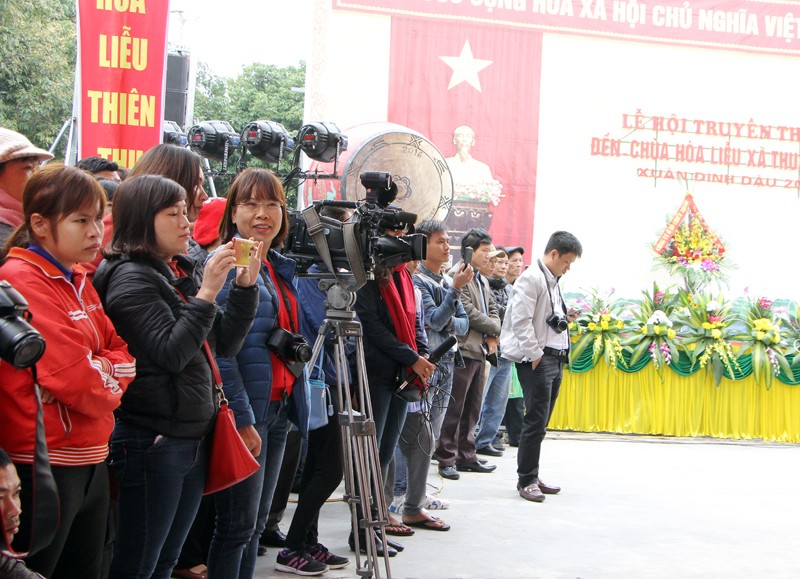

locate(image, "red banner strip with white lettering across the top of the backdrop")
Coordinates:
334 0 800 56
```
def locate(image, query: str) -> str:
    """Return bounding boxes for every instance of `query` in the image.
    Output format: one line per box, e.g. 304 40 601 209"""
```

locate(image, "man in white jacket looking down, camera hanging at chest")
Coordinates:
500 231 583 503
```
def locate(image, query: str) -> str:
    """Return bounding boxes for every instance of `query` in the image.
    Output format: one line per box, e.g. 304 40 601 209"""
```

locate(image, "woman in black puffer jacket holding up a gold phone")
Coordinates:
94 175 259 579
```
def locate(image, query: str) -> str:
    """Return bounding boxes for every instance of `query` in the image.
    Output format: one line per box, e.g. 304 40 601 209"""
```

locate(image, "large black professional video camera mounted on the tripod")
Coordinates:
284 171 427 291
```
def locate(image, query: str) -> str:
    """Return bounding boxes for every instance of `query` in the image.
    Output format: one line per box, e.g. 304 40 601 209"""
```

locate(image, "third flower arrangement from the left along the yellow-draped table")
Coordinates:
678 289 741 386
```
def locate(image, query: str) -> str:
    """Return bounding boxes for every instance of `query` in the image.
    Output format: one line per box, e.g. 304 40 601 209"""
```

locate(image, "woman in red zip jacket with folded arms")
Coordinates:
0 165 136 578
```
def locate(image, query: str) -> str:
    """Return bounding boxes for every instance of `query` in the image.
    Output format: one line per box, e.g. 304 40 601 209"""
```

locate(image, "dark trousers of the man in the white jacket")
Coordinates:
517 354 562 487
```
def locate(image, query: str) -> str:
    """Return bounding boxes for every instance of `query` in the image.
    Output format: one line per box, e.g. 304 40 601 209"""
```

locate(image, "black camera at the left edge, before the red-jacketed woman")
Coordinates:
0 281 45 368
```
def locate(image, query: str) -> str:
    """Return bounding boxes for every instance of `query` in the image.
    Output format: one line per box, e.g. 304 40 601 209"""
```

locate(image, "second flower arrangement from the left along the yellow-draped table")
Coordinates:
622 283 679 383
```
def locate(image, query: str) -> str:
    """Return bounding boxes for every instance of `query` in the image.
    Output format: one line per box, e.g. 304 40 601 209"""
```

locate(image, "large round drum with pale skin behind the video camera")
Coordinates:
300 123 453 223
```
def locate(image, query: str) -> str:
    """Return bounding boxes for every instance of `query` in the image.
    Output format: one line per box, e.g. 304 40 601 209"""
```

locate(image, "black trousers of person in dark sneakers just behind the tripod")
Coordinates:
286 398 344 551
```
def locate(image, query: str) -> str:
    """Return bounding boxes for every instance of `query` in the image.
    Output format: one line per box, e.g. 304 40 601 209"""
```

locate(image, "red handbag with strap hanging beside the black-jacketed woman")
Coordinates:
203 342 260 495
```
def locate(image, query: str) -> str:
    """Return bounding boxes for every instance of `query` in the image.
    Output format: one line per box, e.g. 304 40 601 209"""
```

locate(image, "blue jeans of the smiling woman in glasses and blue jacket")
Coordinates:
208 401 289 579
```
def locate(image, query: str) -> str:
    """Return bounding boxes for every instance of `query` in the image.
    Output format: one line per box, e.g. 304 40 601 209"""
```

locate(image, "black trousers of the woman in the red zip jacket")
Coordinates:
15 462 109 579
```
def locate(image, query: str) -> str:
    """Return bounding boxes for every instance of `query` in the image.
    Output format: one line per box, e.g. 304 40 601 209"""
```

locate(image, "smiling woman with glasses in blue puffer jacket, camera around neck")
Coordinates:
208 168 312 579
